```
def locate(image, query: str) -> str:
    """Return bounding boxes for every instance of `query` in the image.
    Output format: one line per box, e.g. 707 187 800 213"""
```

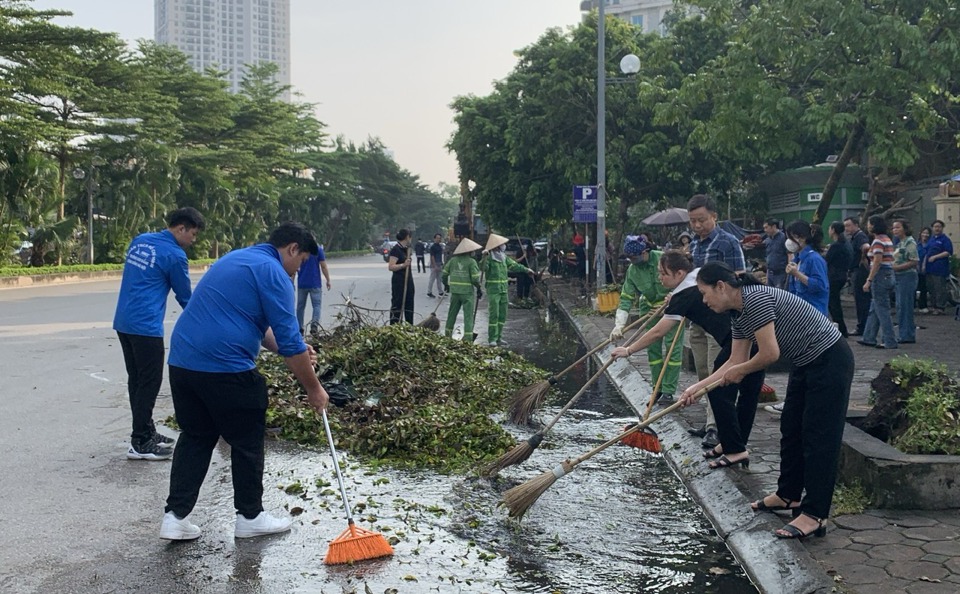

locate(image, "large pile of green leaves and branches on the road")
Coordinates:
259 324 548 472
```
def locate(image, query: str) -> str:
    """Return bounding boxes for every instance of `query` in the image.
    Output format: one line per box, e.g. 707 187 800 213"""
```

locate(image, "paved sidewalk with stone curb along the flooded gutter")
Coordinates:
551 282 960 594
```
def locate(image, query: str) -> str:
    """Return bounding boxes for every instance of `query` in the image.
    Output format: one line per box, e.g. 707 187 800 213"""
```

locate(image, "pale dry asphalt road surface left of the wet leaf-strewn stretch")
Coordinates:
0 255 468 592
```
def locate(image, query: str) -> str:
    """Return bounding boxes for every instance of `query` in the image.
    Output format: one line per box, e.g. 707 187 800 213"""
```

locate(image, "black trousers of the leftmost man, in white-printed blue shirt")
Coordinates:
117 332 164 446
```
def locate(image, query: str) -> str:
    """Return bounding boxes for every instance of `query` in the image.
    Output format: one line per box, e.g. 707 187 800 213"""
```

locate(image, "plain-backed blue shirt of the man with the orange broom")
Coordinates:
168 243 307 373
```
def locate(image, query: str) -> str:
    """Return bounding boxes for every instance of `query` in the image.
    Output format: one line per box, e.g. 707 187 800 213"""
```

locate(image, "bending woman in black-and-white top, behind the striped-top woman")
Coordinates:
611 250 765 469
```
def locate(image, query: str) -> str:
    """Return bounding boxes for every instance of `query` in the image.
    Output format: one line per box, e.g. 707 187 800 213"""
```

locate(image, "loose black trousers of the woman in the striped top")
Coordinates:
777 339 854 519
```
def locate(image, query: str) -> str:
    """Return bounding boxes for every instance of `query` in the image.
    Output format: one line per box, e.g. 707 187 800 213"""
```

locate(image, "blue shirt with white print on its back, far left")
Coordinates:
113 229 190 338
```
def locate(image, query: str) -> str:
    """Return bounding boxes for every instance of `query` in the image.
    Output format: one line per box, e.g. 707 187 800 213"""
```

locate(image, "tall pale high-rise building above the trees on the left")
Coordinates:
153 0 290 92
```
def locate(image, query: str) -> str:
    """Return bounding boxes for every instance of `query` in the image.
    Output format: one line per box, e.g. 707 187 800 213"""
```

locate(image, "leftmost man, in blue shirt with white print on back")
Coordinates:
113 207 205 460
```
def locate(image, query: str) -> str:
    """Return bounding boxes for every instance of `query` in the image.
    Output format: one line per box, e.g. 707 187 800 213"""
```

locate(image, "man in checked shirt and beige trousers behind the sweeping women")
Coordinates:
687 194 746 448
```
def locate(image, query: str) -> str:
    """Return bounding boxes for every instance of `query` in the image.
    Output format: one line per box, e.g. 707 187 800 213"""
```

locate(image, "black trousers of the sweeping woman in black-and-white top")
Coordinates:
707 345 766 454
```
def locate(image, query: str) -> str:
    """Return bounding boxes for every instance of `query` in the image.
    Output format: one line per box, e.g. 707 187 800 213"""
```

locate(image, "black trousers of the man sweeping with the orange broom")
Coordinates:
164 365 267 519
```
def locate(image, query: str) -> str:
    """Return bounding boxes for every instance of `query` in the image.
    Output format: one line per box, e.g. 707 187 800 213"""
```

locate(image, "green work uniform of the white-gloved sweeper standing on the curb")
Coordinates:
619 250 683 394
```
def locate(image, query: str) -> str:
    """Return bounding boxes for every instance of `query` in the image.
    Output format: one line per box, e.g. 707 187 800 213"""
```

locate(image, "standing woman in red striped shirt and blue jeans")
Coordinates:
857 215 897 349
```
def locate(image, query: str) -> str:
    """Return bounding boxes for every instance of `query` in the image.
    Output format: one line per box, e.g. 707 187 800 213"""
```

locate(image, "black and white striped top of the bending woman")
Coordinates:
731 285 841 367
